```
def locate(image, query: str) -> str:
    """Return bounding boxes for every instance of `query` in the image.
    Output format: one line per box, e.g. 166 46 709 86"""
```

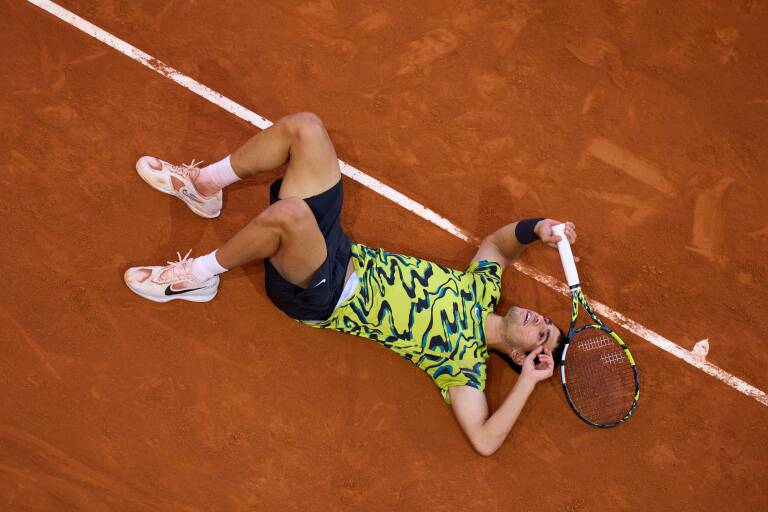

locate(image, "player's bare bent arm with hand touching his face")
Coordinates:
448 346 555 457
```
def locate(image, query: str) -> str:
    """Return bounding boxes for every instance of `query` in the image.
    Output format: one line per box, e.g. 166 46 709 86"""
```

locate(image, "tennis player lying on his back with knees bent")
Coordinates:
125 113 576 455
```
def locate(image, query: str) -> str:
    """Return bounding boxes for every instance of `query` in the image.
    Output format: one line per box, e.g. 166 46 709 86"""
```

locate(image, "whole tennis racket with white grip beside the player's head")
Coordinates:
552 224 640 428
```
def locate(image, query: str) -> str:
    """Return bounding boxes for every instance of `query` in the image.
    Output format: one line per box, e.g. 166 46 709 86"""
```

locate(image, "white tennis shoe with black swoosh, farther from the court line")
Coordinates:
123 250 219 302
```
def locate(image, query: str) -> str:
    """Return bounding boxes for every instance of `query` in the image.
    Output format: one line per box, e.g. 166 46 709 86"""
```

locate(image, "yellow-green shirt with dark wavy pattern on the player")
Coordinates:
300 243 502 403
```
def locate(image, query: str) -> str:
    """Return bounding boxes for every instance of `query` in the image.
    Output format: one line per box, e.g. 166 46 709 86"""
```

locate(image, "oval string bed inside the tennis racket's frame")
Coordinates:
565 329 635 425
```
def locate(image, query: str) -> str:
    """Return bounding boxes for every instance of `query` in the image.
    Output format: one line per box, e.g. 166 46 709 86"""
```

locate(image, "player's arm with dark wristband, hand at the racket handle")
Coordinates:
472 219 578 268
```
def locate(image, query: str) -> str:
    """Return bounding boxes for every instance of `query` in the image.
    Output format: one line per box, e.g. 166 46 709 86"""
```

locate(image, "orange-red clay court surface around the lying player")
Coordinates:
0 0 768 512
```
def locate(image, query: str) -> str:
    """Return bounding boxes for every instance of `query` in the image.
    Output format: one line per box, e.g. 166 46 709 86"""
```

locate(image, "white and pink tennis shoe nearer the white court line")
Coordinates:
136 156 224 219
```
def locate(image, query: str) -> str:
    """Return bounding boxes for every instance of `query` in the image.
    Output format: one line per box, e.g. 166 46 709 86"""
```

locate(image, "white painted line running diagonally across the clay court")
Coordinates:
27 0 768 406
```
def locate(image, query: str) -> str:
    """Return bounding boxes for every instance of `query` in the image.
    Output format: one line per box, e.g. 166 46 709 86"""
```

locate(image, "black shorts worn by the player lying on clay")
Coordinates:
264 178 352 320
